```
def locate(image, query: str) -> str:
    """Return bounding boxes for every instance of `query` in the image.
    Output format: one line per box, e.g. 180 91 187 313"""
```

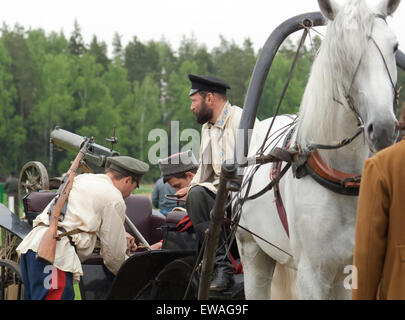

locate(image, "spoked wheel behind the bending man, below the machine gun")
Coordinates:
18 161 49 199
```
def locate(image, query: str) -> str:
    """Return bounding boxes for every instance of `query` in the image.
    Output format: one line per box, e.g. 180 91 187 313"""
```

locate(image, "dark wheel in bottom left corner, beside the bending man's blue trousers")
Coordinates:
0 259 23 300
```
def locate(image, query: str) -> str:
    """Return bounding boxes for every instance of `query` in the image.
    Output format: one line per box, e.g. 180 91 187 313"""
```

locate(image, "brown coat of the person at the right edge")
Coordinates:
352 139 405 300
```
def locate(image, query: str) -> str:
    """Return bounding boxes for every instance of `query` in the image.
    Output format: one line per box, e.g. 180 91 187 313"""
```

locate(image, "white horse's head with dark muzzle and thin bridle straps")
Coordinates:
318 0 400 152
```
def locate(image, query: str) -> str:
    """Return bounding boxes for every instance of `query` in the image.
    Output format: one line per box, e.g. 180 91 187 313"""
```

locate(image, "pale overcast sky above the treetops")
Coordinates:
0 0 405 51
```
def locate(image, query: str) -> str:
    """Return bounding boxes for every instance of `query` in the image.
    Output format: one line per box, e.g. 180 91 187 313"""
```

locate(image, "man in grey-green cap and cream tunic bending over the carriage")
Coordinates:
17 156 149 300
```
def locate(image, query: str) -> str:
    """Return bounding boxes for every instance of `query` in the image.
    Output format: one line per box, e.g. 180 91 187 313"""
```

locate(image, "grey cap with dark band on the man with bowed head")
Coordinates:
158 150 198 176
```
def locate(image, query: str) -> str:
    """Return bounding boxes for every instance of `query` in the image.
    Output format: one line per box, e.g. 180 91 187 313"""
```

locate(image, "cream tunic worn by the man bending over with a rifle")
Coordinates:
17 174 127 282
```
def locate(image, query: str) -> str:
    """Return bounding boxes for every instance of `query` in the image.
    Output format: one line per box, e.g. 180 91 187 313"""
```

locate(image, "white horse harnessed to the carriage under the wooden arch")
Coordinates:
236 0 400 299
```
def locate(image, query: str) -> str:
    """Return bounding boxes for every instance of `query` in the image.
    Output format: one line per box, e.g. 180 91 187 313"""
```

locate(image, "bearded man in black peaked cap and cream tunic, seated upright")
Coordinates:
177 74 242 291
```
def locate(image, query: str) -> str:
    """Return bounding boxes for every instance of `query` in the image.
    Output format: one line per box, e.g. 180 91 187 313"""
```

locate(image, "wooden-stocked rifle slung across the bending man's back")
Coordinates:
35 138 93 264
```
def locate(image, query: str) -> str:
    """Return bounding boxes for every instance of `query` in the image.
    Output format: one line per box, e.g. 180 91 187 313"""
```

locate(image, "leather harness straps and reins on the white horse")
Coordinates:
229 14 401 256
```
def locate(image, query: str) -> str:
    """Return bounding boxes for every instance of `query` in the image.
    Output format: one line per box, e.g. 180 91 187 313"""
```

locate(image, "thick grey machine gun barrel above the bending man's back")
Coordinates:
51 127 120 173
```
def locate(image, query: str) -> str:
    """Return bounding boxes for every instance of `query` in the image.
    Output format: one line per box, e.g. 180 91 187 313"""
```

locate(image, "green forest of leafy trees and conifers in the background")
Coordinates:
0 21 405 182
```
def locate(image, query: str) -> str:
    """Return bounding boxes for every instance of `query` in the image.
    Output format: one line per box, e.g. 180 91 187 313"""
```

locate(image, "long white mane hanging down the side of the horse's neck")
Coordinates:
297 0 374 148
